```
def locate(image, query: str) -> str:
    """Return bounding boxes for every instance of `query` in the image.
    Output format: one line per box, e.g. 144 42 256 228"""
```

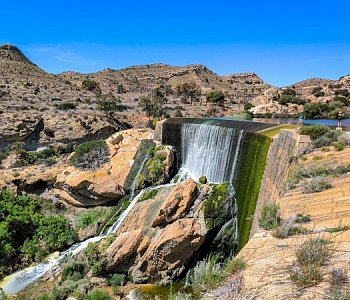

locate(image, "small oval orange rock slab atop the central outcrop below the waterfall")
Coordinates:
152 179 198 227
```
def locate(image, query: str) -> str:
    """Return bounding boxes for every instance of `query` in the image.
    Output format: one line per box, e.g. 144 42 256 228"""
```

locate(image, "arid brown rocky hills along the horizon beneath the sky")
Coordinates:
0 44 350 120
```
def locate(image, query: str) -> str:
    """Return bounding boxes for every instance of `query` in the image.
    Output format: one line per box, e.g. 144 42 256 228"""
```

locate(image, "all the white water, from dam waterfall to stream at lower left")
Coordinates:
0 124 243 294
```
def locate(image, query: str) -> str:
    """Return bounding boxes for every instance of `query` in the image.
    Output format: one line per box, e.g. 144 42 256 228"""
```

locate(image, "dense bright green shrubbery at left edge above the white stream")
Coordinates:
0 190 76 277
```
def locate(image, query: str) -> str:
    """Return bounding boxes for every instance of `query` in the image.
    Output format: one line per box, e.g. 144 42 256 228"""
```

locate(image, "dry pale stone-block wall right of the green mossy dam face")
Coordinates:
250 129 310 237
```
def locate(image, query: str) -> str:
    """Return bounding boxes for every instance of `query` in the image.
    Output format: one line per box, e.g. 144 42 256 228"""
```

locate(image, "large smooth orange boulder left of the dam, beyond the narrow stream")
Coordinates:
55 129 150 206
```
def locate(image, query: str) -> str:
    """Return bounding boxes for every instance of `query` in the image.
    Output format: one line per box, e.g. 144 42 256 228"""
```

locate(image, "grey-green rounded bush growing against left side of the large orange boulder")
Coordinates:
71 140 109 169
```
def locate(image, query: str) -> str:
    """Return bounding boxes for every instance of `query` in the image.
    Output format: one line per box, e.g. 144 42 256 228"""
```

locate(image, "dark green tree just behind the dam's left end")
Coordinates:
139 89 168 120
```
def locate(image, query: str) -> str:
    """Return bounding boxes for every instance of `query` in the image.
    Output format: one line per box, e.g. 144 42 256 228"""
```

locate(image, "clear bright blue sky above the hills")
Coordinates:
0 0 350 86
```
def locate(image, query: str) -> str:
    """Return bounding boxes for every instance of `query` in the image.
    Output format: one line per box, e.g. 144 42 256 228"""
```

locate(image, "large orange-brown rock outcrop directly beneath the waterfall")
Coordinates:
106 179 232 283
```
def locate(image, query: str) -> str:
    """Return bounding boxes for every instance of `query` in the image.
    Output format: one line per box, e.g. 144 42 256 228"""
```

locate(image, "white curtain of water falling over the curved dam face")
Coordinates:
181 123 243 183
